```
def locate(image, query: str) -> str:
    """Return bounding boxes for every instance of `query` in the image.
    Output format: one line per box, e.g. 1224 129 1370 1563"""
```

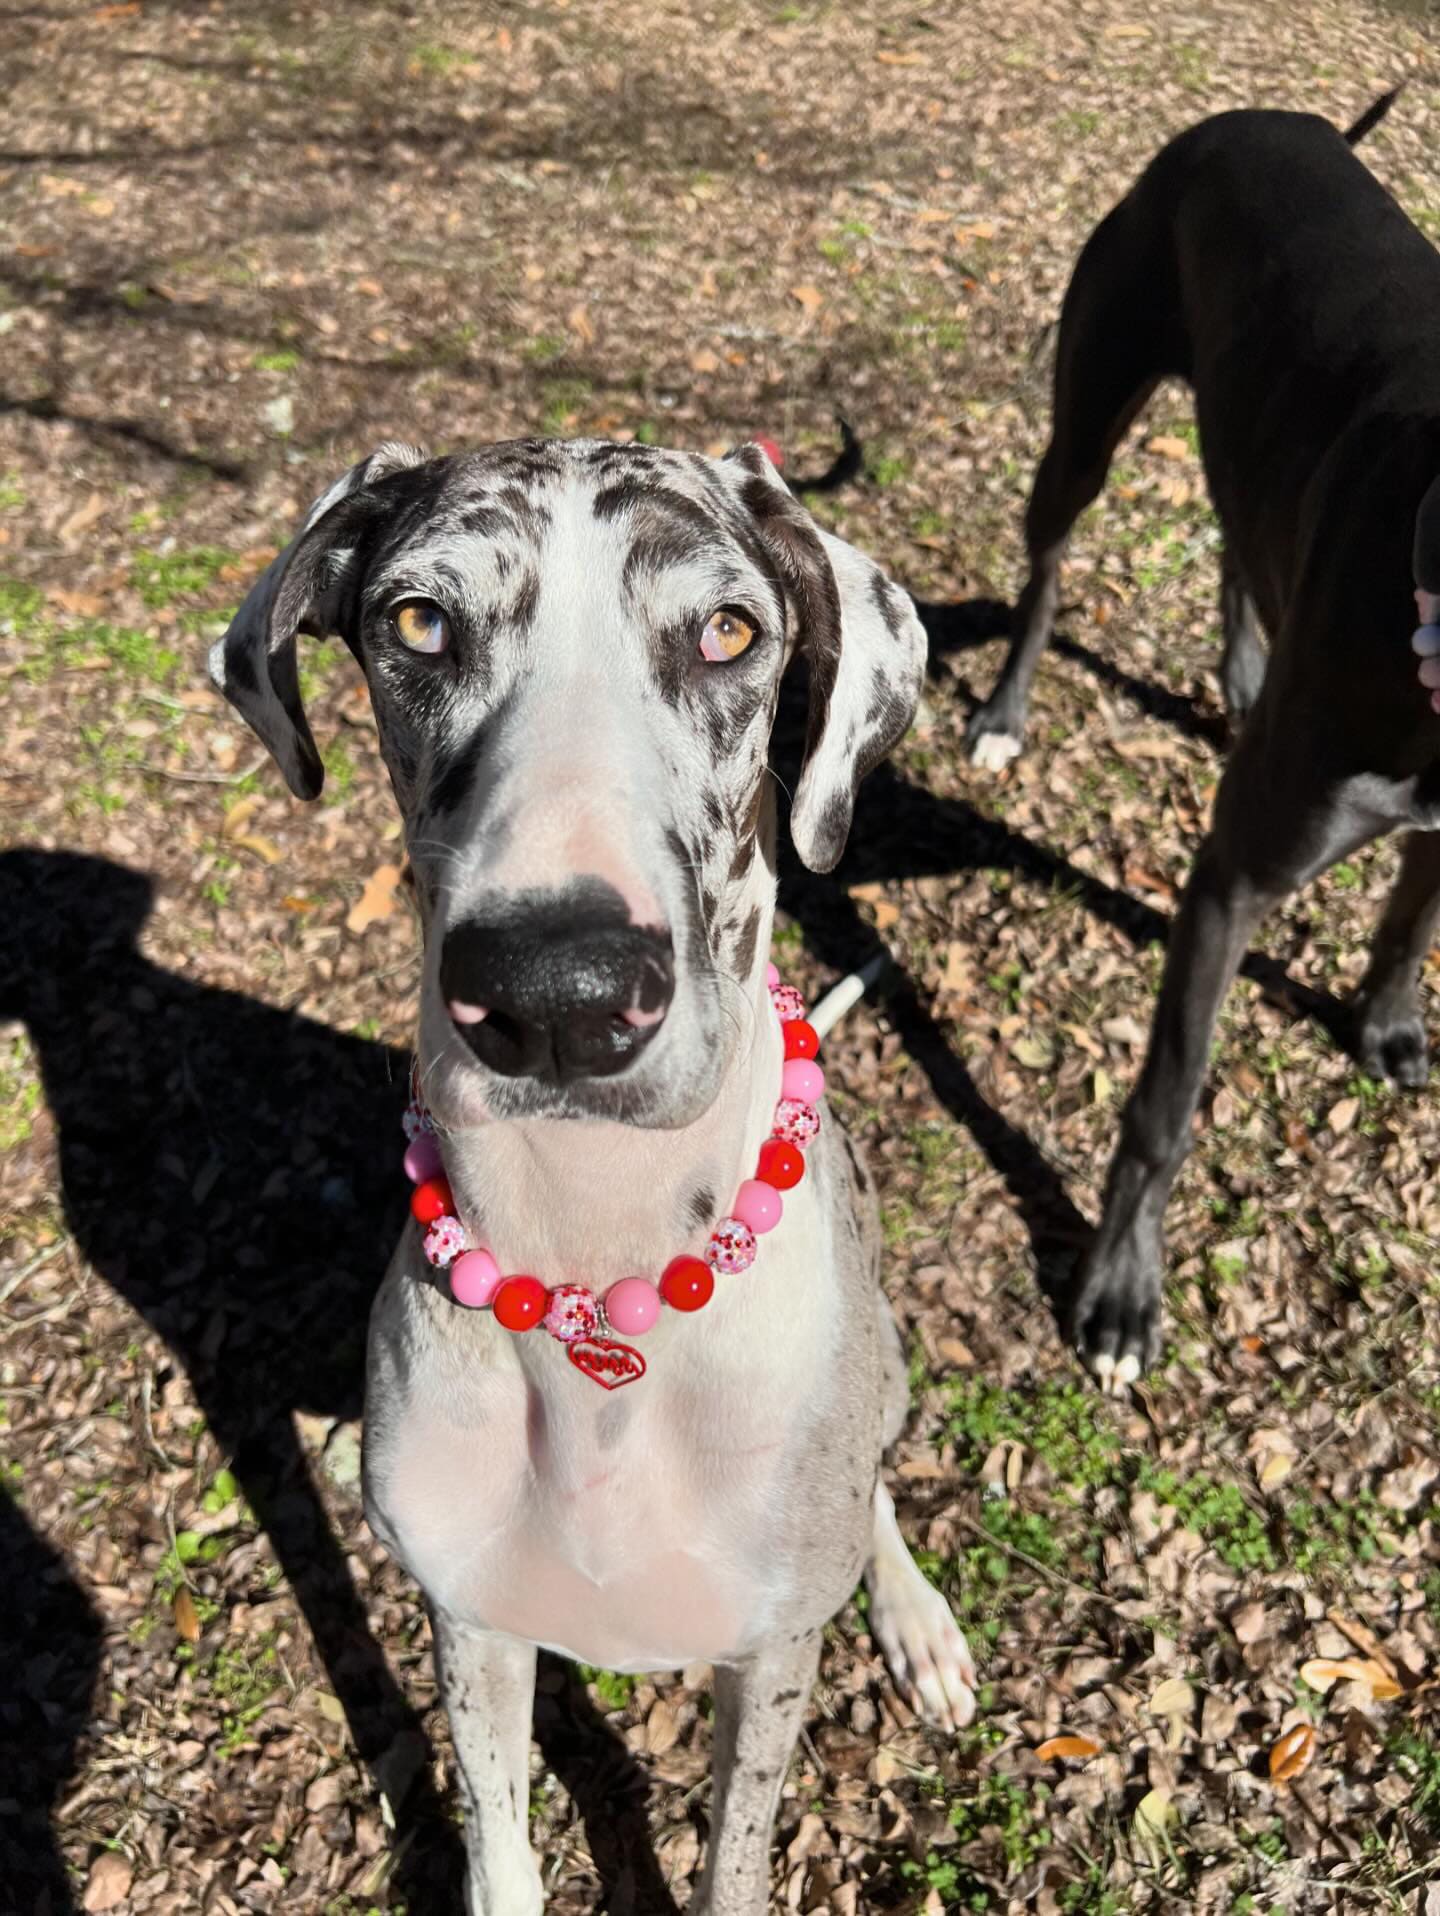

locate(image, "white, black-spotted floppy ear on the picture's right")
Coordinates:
730 445 927 872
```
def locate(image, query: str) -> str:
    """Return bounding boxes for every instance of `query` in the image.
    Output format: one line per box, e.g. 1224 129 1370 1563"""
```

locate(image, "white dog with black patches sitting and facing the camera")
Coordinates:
213 441 975 1916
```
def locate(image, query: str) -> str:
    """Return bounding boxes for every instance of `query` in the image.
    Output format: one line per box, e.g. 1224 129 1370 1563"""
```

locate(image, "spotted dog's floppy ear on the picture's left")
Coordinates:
211 441 425 799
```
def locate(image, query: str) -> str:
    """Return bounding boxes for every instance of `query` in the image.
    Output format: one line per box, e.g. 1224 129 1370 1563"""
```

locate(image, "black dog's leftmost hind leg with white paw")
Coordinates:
965 205 1166 770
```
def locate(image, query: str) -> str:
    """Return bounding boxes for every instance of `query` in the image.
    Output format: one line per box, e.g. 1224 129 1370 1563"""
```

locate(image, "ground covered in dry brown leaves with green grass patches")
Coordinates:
0 0 1440 1916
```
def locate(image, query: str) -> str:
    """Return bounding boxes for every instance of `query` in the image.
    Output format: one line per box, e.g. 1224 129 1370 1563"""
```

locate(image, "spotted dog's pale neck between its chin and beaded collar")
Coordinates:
442 931 783 1291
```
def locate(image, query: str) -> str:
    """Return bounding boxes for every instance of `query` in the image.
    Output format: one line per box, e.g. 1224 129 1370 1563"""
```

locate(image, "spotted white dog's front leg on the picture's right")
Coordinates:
691 1631 820 1916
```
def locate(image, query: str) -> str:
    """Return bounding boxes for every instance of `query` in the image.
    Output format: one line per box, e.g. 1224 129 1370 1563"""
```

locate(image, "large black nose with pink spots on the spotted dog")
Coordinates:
440 887 674 1084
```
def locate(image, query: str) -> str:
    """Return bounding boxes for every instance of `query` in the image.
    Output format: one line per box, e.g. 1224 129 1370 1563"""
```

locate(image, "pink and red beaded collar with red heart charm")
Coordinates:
404 966 825 1391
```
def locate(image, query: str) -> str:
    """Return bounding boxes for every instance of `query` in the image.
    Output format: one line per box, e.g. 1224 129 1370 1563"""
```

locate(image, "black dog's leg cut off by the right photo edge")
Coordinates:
1354 832 1440 1090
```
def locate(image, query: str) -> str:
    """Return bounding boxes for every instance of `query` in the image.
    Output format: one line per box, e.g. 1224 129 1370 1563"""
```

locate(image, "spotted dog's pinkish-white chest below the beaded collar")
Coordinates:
368 1351 802 1669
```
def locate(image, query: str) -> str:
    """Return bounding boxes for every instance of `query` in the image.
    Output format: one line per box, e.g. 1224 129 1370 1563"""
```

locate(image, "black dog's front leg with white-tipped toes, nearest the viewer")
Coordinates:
1070 701 1384 1387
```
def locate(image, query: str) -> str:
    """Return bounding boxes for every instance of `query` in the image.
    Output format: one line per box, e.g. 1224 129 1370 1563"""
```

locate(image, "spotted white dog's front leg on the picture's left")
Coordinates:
433 1611 544 1916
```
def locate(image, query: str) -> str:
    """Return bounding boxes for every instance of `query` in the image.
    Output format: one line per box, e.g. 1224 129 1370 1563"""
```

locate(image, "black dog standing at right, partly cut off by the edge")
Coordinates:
969 94 1440 1383
